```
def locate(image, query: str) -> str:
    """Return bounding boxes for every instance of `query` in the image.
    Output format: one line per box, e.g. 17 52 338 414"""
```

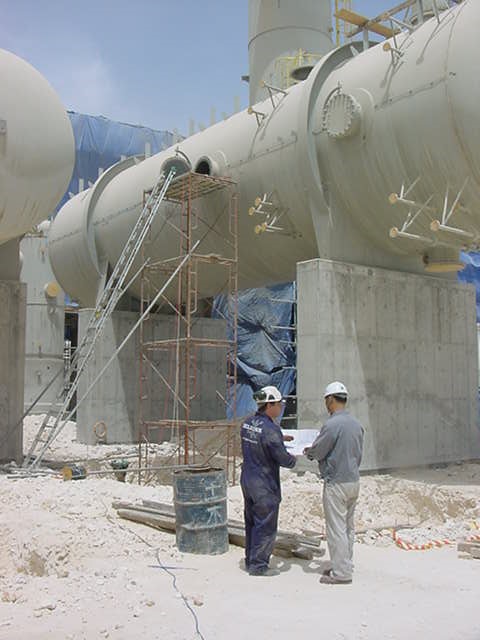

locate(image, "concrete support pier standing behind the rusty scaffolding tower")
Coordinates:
77 309 226 443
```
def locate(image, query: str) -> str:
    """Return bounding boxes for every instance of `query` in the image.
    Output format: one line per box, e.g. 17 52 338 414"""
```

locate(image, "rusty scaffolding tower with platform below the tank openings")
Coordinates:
138 172 238 483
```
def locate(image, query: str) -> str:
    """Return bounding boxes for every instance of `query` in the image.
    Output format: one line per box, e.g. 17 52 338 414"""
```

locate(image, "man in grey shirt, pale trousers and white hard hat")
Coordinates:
304 382 364 584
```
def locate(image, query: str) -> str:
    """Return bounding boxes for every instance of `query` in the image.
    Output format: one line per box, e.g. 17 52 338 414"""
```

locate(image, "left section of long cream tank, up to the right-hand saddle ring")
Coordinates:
49 85 317 305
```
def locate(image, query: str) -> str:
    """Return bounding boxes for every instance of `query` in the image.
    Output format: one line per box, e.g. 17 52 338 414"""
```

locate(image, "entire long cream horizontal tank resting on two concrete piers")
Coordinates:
50 0 480 305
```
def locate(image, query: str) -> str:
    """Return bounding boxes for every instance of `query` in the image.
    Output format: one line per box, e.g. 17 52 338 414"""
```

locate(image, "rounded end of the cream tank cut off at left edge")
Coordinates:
0 49 75 244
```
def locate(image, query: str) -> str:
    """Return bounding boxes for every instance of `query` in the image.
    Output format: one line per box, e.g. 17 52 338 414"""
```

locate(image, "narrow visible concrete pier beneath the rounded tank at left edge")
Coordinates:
0 281 26 464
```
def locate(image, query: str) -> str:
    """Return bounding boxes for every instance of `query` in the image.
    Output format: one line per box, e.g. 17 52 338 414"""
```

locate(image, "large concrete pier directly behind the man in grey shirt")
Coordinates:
297 260 480 469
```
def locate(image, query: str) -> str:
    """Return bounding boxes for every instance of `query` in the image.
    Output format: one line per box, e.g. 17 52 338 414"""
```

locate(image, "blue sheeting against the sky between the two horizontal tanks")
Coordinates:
58 111 174 209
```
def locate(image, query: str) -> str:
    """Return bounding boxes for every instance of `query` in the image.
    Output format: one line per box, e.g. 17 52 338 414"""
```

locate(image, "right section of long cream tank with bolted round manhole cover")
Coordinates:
307 0 480 269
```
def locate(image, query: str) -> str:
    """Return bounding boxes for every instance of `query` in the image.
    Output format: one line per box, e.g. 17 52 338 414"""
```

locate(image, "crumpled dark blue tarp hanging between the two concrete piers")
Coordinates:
212 283 296 418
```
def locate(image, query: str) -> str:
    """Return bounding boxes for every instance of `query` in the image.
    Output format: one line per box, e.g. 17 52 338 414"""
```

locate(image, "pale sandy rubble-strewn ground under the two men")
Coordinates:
0 418 480 640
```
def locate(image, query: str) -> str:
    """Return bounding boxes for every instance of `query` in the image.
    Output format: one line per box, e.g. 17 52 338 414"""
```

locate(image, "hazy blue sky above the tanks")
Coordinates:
0 0 386 133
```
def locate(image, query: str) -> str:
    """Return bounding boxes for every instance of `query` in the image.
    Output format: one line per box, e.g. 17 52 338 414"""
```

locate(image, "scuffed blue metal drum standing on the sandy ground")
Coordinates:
173 467 228 555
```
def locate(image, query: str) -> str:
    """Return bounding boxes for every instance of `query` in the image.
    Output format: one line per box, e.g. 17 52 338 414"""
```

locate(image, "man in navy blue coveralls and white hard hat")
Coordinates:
240 387 297 576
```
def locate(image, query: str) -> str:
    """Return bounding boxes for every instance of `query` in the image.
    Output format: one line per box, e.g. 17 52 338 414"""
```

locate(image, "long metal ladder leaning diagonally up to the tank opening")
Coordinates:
23 169 175 469
